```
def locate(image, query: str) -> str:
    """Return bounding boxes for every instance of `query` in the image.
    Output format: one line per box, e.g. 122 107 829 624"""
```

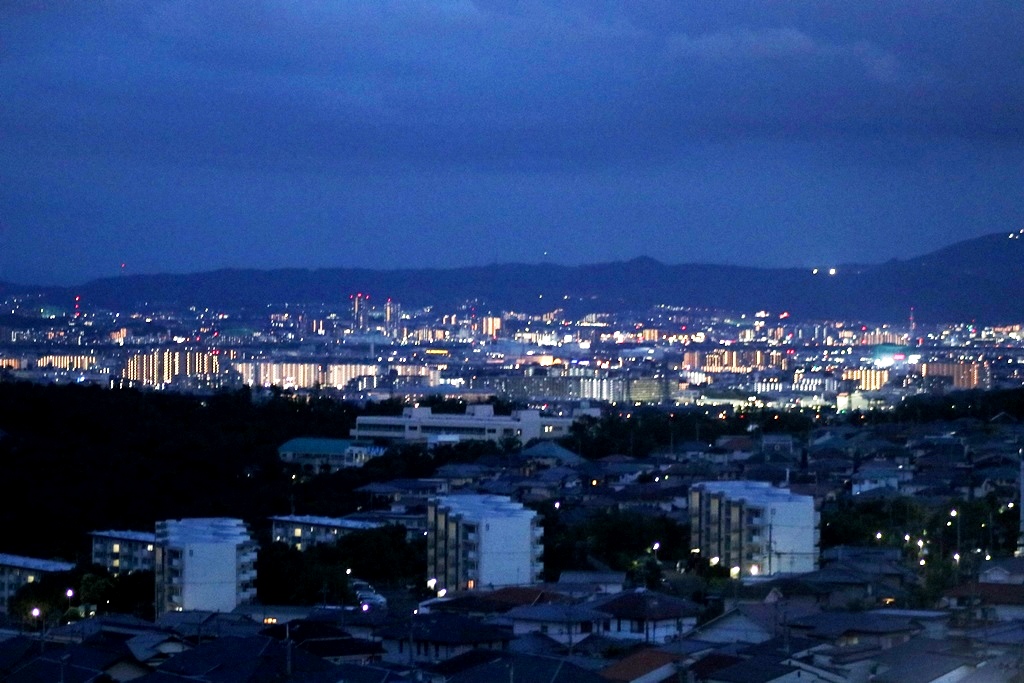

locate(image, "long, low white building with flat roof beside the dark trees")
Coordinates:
350 404 573 443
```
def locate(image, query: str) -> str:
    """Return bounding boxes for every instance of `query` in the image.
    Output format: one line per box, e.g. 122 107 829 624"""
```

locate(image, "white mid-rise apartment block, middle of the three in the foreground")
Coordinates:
427 494 544 592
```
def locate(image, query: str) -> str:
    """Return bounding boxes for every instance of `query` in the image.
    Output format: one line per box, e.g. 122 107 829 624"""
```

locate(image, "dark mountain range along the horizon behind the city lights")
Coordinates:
0 230 1024 324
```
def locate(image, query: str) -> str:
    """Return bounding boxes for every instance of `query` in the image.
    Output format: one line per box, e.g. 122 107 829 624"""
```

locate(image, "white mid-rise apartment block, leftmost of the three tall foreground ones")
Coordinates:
154 517 257 614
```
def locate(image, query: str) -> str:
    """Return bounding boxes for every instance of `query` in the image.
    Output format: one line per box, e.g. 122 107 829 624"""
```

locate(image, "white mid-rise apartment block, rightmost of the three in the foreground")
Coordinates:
689 481 819 579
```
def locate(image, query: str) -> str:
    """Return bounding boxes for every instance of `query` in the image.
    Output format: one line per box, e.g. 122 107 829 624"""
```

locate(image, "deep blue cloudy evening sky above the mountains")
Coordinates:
0 0 1024 284
